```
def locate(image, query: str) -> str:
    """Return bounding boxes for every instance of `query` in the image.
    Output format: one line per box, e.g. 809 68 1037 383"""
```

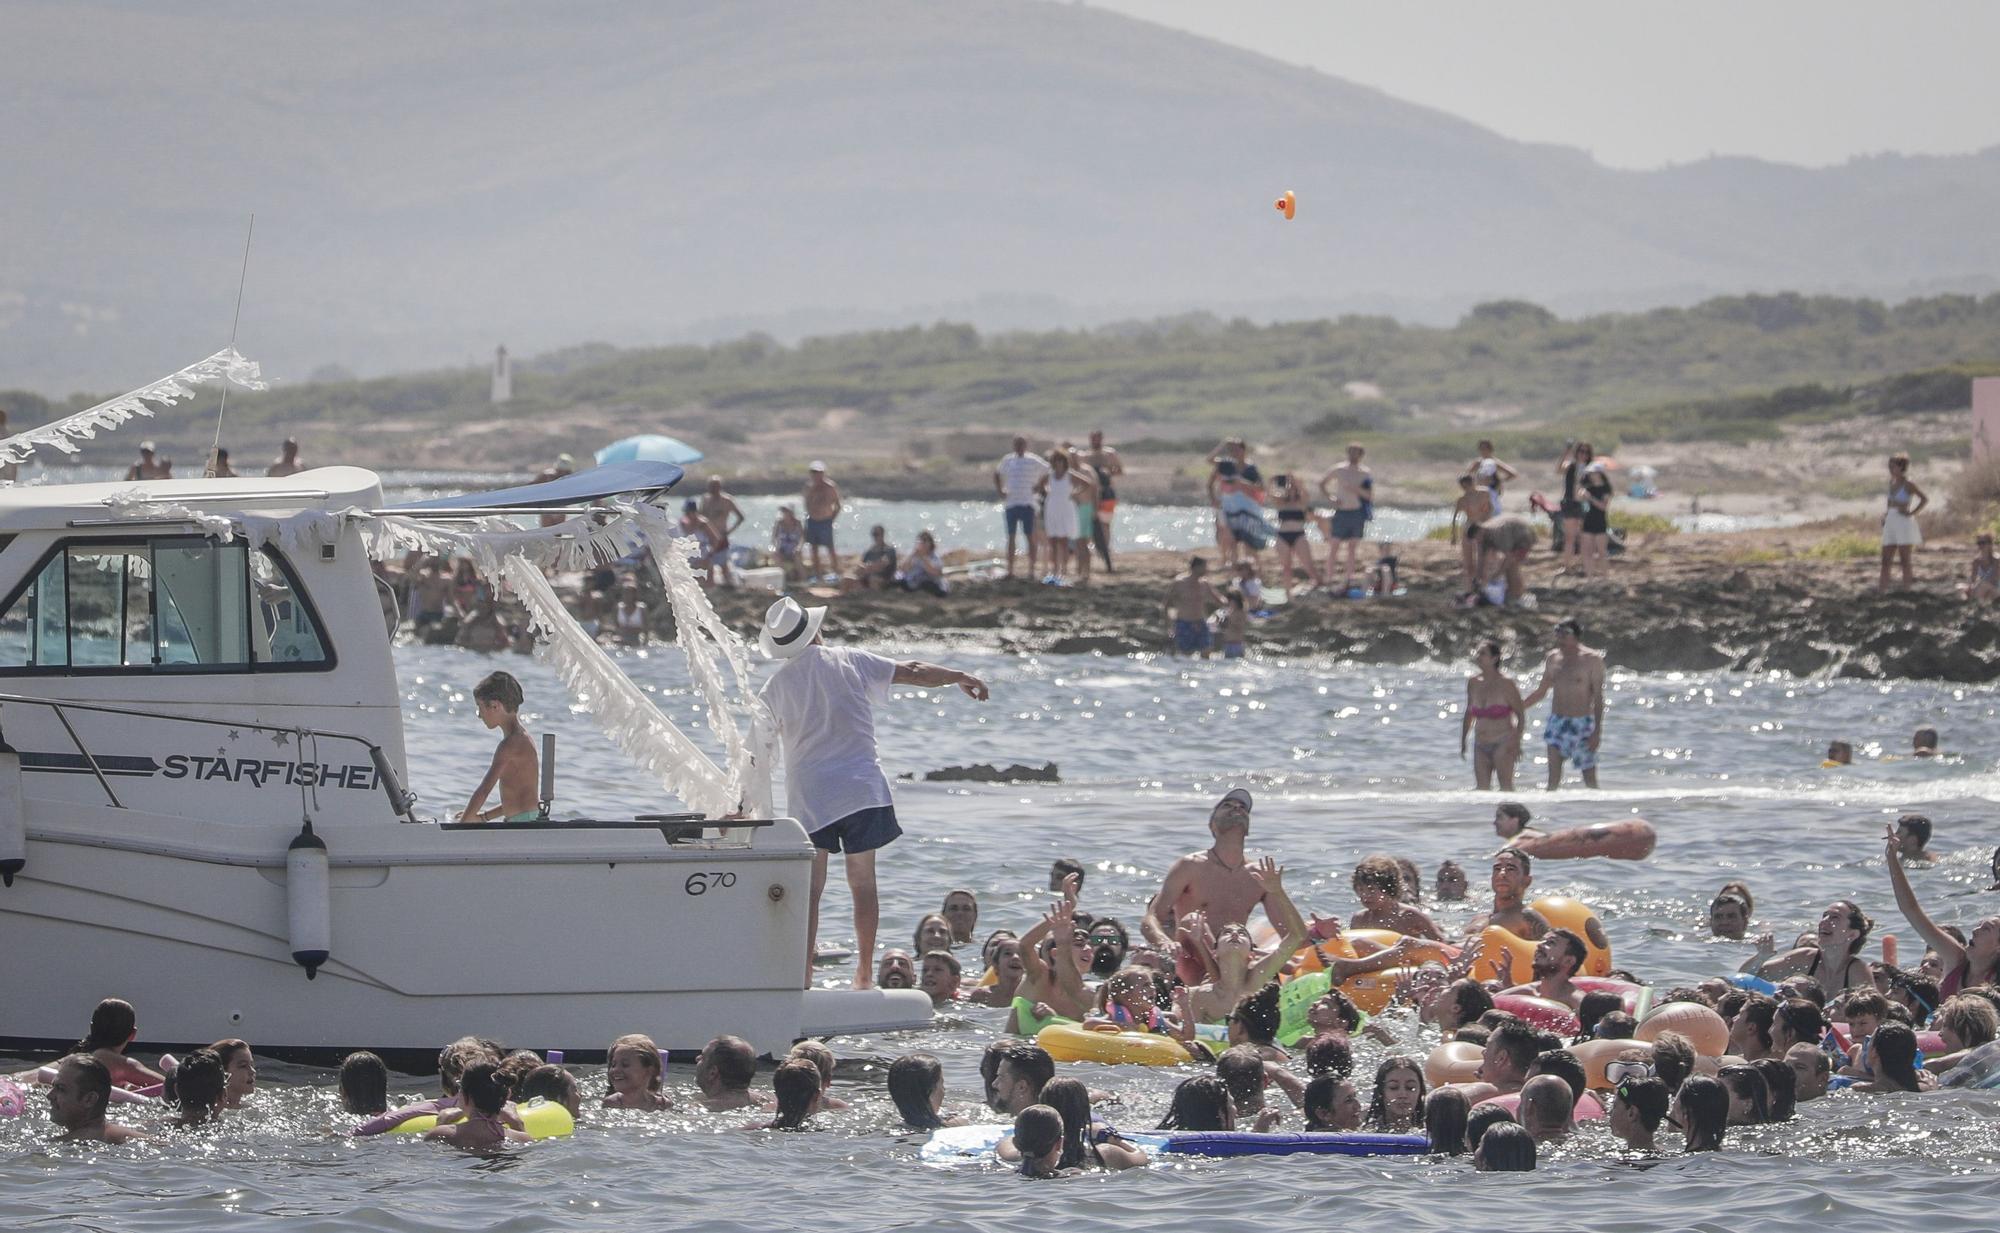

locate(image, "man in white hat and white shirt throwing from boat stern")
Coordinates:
758 598 986 989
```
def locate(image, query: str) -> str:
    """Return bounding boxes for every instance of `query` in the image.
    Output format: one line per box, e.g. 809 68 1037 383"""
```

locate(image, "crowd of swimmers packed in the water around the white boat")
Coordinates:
14 791 2000 1175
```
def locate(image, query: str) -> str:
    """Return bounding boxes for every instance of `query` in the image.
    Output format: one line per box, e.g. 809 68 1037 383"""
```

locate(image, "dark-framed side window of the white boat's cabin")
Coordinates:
0 536 332 673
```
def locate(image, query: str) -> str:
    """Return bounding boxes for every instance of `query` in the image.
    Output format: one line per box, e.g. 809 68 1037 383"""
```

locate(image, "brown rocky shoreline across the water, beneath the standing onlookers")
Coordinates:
692 530 2000 683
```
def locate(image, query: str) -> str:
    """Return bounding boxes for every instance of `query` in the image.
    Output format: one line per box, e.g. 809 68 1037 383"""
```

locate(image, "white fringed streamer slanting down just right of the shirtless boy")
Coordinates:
500 556 738 819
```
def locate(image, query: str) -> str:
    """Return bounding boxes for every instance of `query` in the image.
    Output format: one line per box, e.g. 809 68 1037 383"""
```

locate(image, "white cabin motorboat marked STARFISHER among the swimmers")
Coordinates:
0 458 930 1069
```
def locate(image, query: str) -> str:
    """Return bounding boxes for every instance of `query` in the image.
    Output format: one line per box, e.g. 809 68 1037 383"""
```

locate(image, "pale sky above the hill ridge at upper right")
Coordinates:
1088 0 2000 168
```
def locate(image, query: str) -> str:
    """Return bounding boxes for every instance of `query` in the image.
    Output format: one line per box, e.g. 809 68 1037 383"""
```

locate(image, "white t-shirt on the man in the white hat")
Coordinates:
764 645 896 835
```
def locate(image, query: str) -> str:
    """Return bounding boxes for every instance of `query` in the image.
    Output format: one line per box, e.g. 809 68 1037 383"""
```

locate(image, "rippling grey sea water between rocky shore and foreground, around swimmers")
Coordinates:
0 643 2000 1233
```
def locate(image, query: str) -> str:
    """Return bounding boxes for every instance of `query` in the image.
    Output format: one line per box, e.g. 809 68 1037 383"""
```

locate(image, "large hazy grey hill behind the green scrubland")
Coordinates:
0 0 2000 390
